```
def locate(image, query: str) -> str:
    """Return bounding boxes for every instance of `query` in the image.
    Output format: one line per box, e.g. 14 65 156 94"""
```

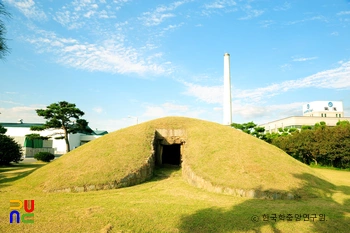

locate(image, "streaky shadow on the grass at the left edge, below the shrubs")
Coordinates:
0 163 45 188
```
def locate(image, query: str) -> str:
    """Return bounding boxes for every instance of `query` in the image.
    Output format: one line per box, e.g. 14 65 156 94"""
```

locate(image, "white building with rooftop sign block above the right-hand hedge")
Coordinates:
259 101 350 133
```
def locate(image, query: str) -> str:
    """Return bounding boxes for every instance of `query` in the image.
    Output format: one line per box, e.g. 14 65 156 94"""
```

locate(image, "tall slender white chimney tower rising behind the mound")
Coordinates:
223 53 232 125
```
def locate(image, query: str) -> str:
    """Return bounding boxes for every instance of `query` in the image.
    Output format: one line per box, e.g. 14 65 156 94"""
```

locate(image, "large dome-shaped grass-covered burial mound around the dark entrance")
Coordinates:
20 117 330 196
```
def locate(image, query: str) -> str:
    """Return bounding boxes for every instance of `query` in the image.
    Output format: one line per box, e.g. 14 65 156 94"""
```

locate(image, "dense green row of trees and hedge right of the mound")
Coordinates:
232 121 350 169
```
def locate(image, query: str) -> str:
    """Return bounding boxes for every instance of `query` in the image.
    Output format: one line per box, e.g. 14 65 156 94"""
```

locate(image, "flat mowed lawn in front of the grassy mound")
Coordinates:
0 164 350 233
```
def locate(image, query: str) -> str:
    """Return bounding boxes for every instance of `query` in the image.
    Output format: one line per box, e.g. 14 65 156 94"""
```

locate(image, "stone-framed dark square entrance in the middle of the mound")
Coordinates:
153 129 186 166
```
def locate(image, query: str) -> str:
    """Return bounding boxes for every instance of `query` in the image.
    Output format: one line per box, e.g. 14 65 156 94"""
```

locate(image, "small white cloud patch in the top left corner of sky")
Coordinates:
5 0 47 20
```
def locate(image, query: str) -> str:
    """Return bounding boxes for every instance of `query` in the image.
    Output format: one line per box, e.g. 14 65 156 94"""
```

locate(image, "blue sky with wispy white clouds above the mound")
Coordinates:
0 0 350 131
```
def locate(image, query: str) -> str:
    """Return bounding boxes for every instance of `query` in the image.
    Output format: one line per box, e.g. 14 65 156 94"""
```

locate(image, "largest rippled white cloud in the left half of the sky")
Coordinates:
27 30 171 75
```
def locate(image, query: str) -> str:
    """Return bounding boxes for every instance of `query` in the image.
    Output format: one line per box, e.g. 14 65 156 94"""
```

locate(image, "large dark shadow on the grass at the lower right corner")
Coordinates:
179 174 350 233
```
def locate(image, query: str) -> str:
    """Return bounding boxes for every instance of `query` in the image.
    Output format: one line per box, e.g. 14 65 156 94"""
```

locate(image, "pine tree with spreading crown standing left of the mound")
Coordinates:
31 101 92 152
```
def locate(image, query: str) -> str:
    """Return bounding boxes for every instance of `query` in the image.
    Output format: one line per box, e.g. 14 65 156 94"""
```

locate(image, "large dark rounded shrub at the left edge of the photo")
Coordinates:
0 134 22 165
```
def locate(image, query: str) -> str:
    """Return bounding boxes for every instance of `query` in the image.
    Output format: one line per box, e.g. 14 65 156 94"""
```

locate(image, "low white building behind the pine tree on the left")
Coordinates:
0 120 108 157
